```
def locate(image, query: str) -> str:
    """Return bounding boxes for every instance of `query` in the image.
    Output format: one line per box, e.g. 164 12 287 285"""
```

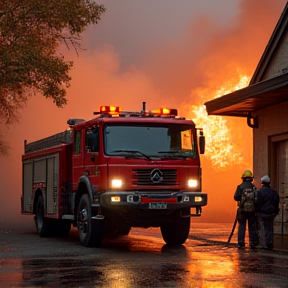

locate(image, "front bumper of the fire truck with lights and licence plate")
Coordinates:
100 191 207 216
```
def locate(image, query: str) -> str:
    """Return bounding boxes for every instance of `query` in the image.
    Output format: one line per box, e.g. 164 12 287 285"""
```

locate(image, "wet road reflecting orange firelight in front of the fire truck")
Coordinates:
0 224 288 288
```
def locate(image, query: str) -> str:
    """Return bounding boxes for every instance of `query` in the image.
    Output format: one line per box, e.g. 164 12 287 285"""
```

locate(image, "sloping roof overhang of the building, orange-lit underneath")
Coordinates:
204 73 288 117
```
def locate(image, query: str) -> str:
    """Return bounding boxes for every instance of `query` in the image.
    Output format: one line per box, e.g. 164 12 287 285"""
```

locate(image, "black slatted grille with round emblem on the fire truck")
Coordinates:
132 169 178 186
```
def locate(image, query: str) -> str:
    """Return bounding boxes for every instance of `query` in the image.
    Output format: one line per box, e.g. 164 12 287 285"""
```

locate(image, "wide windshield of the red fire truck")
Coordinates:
104 124 197 160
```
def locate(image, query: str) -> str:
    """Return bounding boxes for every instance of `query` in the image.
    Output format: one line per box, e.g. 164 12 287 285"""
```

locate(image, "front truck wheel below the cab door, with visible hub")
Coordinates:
77 194 104 246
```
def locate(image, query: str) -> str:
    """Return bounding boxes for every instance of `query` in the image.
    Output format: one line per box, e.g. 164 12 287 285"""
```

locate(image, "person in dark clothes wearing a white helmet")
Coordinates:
257 175 279 249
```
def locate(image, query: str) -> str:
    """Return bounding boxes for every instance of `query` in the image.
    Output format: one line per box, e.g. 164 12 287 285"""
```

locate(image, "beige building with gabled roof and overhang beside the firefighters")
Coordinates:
205 3 288 234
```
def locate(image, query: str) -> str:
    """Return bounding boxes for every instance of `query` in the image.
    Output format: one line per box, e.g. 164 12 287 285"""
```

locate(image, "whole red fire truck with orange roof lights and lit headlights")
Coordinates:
21 102 207 246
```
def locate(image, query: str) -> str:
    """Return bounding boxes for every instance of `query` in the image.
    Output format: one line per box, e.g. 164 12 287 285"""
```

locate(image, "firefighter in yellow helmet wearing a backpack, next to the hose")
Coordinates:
234 170 259 249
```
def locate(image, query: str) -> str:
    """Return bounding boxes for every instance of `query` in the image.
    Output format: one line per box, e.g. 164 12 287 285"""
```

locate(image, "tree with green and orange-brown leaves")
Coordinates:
0 0 106 154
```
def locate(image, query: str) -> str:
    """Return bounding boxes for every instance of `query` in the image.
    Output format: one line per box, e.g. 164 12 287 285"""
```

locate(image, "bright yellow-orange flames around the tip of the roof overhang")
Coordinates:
190 76 249 169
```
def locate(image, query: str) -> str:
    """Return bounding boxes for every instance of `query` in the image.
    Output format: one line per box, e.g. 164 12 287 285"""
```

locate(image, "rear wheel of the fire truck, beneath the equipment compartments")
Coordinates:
35 196 51 237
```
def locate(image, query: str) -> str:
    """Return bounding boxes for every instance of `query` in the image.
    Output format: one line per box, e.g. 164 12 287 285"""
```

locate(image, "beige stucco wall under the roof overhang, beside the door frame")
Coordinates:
253 102 288 187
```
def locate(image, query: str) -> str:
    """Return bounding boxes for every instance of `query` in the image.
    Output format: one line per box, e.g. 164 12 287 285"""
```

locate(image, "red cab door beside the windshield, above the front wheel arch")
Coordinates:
84 127 100 186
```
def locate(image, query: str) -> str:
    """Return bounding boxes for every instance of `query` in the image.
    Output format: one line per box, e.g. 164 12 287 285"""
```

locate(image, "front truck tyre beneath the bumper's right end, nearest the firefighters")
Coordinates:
160 212 190 245
